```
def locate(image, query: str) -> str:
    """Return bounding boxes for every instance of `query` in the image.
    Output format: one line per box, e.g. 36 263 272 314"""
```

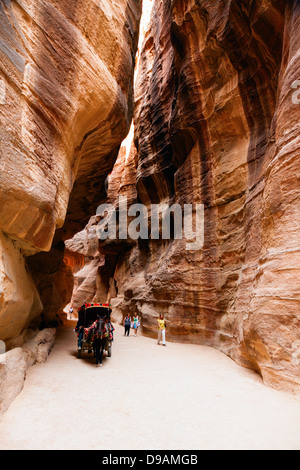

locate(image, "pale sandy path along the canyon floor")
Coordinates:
0 327 300 450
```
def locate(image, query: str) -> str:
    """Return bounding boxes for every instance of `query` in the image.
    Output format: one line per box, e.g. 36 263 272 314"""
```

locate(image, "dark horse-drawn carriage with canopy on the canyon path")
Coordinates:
75 304 114 365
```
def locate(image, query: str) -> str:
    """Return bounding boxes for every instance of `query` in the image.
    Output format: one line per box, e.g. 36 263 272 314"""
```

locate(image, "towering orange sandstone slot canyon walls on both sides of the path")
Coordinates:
0 0 300 450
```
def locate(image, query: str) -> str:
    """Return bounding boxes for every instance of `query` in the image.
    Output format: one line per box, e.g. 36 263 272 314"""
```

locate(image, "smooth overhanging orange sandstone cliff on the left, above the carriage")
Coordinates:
0 0 141 339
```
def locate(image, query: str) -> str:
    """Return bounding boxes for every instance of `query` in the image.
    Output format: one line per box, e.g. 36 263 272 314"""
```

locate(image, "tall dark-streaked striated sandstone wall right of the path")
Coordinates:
68 0 300 391
